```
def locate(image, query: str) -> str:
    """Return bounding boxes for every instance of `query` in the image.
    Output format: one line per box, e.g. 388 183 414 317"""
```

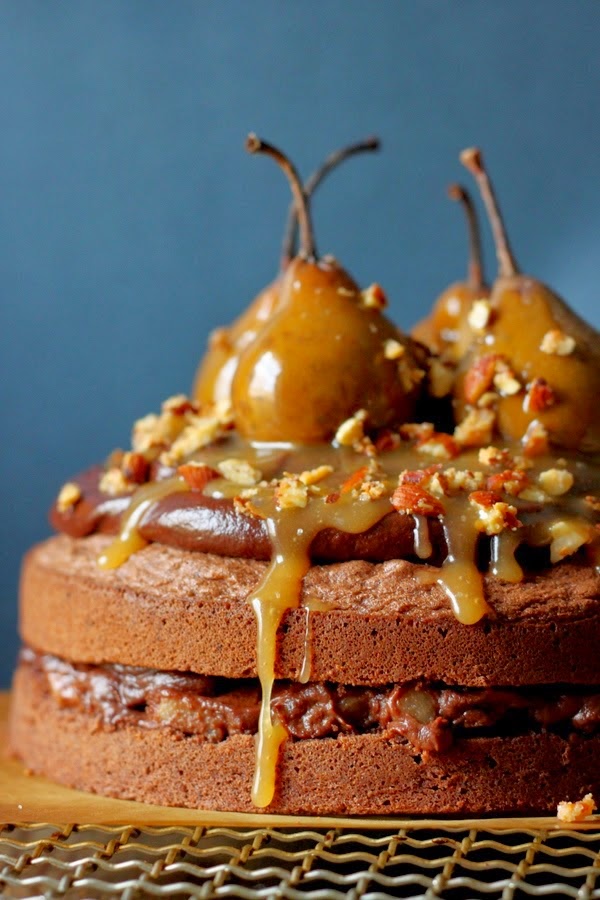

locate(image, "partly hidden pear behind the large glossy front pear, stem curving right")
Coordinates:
192 137 380 410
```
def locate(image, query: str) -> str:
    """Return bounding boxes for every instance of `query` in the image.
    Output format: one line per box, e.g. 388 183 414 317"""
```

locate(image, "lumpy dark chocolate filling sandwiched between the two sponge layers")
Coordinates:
20 648 600 754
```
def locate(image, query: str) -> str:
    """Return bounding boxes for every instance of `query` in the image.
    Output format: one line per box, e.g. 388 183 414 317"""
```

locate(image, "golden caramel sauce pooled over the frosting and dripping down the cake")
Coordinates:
81 433 600 808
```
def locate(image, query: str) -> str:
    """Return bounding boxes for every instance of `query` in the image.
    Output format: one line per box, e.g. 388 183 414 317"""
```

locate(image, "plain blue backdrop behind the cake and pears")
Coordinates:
0 0 600 684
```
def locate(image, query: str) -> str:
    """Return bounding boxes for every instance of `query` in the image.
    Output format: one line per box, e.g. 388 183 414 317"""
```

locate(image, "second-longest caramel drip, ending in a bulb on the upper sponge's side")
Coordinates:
438 497 490 625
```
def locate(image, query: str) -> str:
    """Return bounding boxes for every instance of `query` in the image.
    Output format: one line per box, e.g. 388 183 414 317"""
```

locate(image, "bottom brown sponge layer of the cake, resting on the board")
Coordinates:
10 667 600 815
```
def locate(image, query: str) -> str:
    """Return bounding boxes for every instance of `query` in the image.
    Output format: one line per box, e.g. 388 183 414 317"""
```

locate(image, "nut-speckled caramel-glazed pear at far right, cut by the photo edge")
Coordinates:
455 149 600 451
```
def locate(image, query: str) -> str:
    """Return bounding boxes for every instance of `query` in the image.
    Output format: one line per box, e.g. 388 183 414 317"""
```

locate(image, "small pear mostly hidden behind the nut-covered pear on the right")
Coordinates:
411 184 489 362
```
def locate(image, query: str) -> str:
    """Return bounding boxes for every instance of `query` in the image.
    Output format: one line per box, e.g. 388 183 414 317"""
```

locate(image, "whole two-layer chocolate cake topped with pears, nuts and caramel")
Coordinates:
10 138 600 815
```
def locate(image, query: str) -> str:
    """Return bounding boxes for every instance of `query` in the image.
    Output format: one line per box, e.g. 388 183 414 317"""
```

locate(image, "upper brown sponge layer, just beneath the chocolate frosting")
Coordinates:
20 535 600 686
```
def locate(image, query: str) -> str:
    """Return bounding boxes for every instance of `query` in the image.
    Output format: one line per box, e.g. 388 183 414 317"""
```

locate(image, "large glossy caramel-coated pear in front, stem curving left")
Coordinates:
232 135 423 443
